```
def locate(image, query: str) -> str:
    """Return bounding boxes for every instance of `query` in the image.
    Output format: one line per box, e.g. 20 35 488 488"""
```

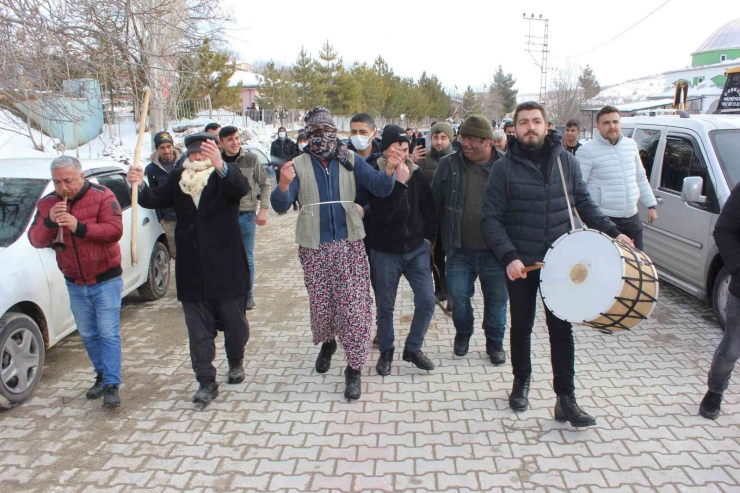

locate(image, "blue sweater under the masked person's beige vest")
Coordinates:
270 154 396 243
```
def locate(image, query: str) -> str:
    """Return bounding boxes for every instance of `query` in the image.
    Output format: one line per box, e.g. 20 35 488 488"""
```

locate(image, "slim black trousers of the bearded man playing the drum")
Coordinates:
506 271 577 394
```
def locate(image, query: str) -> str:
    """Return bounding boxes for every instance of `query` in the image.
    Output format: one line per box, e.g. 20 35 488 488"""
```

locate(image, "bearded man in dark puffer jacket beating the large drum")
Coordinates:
481 102 632 427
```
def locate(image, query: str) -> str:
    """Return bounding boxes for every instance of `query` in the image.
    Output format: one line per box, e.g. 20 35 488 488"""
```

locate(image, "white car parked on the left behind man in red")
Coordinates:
0 159 170 409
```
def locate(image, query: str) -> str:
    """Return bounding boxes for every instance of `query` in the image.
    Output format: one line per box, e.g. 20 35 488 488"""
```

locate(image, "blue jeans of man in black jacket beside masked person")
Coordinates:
370 241 436 353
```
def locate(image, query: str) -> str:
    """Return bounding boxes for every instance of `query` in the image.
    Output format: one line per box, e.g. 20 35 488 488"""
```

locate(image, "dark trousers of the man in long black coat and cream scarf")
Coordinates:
182 297 249 384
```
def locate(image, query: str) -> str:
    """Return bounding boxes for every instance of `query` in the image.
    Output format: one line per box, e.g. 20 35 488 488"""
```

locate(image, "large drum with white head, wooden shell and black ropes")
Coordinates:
540 229 658 332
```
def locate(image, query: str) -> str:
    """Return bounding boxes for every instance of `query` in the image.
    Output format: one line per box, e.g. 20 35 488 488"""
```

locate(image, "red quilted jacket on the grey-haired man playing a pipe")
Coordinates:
28 180 123 285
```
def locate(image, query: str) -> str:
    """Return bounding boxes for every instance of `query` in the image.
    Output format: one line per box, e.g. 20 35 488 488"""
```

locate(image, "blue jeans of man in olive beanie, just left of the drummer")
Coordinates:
447 248 509 343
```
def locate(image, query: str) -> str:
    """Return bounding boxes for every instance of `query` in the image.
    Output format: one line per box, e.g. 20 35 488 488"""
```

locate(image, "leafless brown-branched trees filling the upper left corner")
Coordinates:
0 0 227 144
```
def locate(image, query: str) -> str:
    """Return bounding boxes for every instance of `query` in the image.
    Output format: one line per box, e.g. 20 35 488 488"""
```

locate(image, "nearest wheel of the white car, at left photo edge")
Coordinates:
0 312 46 409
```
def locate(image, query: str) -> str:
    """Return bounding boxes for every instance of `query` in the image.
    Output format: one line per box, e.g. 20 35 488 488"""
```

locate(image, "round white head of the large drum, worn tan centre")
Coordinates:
540 230 624 324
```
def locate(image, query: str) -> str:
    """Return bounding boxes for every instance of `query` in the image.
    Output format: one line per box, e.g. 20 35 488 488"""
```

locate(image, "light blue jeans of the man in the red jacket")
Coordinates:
67 276 123 385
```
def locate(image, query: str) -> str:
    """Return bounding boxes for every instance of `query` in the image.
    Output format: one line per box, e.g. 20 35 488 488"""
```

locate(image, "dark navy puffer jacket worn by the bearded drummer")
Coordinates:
481 132 619 266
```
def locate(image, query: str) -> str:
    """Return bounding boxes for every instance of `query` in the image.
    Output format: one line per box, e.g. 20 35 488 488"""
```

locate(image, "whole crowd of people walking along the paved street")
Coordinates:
29 102 740 427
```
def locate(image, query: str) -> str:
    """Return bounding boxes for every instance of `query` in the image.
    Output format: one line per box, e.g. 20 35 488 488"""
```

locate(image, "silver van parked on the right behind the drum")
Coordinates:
622 115 740 328
